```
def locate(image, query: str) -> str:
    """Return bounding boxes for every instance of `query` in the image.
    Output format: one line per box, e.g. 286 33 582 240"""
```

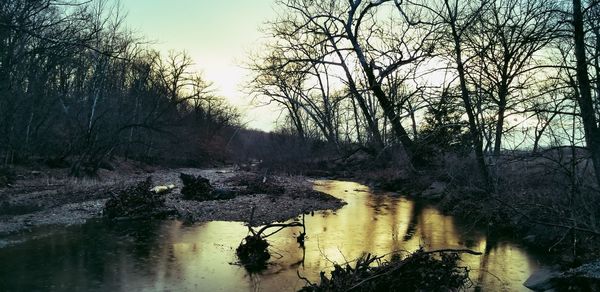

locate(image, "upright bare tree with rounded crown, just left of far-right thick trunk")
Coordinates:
464 0 559 155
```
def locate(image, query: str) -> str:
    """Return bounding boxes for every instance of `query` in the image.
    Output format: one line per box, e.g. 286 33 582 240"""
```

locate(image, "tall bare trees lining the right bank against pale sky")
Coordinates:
249 0 600 185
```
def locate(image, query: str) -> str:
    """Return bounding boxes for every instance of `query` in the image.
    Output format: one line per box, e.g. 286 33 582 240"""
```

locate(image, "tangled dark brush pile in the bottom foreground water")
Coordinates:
300 249 470 292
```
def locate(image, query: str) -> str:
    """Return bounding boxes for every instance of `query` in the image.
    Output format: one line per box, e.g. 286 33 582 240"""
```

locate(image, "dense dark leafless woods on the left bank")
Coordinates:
0 0 240 175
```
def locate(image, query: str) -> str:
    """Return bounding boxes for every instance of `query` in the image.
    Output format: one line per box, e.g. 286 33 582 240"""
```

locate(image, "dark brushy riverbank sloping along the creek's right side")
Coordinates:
302 154 600 291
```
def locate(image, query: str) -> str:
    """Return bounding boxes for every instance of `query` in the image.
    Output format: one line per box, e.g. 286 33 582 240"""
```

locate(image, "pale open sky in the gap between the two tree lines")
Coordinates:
114 0 279 131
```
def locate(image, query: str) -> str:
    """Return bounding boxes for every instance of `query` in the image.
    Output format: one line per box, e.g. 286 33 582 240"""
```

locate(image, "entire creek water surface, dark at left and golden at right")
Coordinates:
0 180 540 291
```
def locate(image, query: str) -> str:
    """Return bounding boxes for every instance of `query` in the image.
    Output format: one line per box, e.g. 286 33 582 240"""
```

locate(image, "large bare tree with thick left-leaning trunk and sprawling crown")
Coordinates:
262 0 432 159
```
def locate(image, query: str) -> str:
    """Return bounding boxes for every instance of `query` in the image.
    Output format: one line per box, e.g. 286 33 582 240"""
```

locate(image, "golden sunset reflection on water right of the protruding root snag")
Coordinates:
258 181 537 291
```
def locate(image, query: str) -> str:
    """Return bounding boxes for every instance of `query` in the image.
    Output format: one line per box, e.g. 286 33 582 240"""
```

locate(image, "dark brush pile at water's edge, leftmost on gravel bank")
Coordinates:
104 177 167 219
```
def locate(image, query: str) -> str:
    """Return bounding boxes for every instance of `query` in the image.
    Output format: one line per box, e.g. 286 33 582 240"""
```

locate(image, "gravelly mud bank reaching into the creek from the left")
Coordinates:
0 168 343 236
